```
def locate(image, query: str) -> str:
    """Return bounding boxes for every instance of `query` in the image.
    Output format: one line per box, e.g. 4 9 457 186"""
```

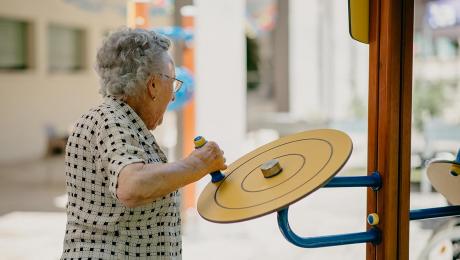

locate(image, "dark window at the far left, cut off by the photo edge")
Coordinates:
0 17 28 70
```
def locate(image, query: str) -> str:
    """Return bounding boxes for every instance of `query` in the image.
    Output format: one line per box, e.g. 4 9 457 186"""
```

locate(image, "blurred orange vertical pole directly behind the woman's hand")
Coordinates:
182 16 196 210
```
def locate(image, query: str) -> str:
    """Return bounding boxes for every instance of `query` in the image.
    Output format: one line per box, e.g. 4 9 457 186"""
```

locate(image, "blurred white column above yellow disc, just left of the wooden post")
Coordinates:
289 0 369 122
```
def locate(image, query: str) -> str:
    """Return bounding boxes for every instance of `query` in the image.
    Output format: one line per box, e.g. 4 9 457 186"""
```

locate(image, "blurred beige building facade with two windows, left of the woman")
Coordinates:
0 0 126 162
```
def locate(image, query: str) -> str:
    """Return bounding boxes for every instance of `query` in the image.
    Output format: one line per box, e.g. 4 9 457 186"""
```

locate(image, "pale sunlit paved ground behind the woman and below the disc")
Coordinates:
0 158 450 260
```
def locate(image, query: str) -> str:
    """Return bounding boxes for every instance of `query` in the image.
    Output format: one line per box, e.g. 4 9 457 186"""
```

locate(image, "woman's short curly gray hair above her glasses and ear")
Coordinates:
95 28 172 97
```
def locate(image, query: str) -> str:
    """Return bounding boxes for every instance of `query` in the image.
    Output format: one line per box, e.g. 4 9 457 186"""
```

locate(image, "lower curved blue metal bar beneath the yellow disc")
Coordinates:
278 207 381 248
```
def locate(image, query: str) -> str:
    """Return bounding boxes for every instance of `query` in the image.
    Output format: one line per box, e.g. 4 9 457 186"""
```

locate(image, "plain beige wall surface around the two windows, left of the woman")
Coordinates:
0 0 126 162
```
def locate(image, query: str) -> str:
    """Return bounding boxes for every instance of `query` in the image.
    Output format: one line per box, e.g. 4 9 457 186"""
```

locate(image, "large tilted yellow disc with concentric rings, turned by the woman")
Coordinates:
198 129 352 223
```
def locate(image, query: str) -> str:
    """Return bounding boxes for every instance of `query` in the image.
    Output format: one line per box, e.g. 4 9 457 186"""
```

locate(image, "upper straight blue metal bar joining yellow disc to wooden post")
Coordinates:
324 172 382 190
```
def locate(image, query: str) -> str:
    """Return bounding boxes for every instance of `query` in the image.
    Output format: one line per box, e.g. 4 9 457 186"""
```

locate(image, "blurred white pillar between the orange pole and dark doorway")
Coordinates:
195 0 246 162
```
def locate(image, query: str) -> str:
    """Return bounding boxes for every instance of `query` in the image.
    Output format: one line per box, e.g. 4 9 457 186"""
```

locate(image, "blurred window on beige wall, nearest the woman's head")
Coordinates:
48 25 85 72
